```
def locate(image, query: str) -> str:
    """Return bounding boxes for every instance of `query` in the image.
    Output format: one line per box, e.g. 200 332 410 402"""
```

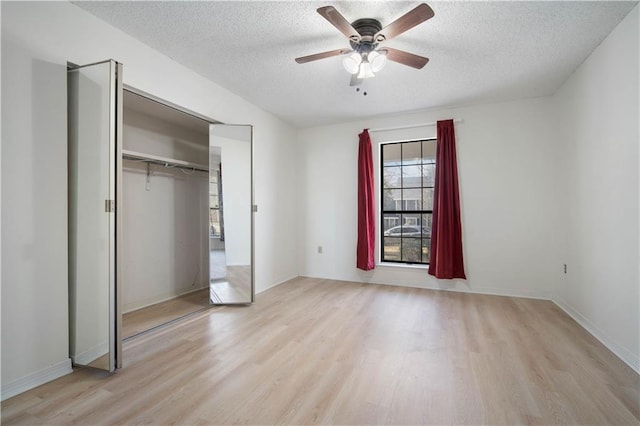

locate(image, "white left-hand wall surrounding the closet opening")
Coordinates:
0 2 297 398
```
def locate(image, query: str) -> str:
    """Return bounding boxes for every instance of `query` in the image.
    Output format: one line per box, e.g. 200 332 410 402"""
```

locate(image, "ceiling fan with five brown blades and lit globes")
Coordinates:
296 3 434 86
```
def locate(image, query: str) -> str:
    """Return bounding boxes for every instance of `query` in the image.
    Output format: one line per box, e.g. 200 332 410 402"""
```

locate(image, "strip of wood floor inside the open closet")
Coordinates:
122 288 210 339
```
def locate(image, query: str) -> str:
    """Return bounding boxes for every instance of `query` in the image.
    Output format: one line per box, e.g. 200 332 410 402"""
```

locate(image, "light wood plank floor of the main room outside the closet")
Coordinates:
2 278 640 425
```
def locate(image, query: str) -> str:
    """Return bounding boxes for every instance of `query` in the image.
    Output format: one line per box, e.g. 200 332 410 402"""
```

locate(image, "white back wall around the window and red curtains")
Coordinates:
298 98 562 297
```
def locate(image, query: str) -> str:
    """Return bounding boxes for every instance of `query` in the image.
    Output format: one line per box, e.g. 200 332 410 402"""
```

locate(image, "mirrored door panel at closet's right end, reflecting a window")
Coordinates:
209 125 254 304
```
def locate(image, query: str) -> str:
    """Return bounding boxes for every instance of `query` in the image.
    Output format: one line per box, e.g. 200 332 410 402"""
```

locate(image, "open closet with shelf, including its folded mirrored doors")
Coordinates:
67 60 252 371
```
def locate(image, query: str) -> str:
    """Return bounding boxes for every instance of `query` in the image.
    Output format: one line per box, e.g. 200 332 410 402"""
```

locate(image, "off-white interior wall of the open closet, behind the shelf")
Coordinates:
120 91 209 313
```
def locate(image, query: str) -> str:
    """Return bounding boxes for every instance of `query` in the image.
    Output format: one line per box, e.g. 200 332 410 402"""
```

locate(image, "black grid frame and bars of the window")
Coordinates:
378 136 437 268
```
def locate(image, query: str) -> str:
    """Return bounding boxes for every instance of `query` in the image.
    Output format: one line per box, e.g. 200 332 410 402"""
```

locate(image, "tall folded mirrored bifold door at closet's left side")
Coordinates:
67 60 122 371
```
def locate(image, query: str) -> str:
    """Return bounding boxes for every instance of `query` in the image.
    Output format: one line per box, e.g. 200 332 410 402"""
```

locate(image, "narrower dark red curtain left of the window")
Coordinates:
356 129 376 271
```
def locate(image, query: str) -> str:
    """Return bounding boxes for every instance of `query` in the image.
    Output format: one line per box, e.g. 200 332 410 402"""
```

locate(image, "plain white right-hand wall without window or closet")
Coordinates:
554 6 640 371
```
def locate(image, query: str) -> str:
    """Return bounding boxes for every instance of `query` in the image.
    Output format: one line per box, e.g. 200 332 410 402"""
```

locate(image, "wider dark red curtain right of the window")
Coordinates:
429 120 467 279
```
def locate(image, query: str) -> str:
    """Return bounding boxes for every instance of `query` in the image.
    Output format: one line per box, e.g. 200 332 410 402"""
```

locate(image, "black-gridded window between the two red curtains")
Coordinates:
380 139 436 265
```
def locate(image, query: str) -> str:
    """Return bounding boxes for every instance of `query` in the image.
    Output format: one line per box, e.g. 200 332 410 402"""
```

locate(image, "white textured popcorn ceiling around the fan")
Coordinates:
74 1 637 127
